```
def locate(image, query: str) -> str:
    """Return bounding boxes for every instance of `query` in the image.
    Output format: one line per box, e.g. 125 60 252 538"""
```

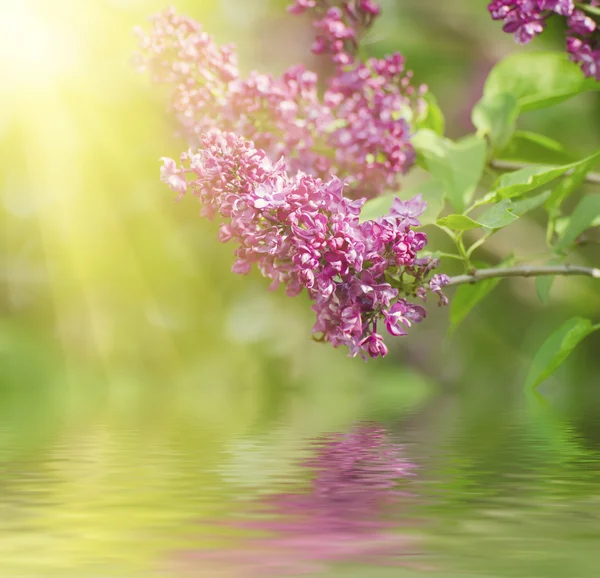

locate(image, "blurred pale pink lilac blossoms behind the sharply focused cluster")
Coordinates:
137 0 425 198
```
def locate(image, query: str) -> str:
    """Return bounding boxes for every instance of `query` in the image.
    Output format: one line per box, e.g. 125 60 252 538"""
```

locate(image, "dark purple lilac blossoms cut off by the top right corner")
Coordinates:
488 0 600 80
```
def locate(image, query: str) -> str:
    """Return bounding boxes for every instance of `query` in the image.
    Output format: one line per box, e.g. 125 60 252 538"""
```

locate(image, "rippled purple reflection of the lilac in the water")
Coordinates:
171 424 415 578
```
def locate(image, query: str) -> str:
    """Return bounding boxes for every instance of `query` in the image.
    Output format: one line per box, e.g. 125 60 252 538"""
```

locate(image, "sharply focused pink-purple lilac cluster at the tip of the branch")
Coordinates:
161 130 448 358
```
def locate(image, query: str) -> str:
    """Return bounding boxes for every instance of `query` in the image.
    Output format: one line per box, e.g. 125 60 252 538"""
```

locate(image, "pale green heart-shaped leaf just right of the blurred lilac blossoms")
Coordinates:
413 129 486 212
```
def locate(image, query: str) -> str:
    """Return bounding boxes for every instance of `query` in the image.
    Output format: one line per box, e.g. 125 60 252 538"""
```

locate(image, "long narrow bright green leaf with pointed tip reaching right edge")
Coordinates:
494 150 600 199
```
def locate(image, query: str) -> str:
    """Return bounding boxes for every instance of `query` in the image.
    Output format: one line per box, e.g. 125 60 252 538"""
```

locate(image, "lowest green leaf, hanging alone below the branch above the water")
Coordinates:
525 317 594 389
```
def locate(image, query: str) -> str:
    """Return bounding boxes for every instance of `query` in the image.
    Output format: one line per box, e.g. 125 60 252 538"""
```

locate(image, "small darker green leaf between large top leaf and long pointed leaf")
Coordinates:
495 131 575 165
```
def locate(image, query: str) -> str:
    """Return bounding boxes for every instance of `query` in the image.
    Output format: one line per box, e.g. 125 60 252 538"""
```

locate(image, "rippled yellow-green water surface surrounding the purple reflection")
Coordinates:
0 340 600 578
